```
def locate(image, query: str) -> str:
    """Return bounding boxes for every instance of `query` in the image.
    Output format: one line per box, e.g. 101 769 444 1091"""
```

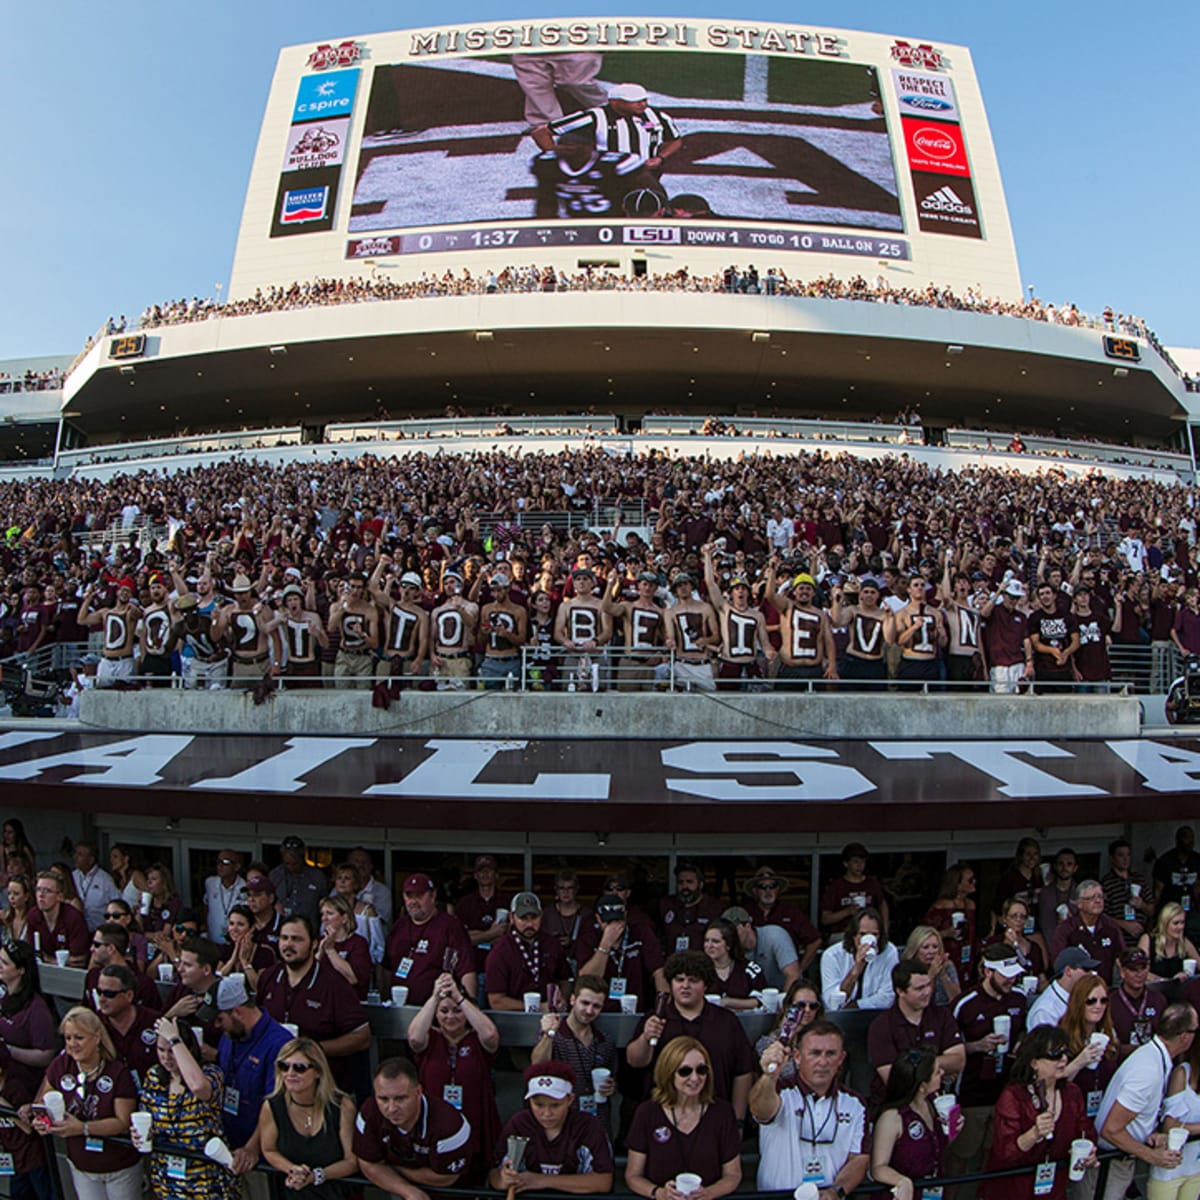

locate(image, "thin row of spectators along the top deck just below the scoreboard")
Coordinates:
65 264 1180 386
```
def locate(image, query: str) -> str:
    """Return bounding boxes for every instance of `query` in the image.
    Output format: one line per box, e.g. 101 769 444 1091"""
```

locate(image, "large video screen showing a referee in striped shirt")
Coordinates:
349 50 904 234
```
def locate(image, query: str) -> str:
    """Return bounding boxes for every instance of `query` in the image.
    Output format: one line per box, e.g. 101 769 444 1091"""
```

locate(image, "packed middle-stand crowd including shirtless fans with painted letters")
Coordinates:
0 446 1200 700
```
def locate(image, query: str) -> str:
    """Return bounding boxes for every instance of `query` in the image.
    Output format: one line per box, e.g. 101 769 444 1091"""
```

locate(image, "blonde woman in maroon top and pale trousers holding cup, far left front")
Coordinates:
20 1008 142 1200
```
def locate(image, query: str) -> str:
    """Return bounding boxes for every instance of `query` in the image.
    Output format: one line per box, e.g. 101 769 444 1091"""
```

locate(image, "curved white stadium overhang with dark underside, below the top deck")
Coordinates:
66 293 1187 439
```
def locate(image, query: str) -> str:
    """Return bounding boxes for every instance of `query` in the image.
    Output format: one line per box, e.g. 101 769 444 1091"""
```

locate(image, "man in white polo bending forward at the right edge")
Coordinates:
1096 1004 1196 1200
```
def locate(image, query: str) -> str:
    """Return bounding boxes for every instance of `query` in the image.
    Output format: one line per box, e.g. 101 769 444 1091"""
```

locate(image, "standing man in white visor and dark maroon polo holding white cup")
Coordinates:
946 946 1026 1175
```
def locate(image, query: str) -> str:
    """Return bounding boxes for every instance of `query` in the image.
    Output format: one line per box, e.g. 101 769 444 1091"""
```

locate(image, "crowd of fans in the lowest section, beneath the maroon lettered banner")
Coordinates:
0 818 1200 1200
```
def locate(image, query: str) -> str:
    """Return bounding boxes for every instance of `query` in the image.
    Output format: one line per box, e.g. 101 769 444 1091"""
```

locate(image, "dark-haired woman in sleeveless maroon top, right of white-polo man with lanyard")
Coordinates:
871 1048 958 1200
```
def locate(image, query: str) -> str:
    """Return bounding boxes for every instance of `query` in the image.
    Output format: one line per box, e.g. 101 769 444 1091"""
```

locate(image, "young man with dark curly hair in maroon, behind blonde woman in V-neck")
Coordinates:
625 950 755 1121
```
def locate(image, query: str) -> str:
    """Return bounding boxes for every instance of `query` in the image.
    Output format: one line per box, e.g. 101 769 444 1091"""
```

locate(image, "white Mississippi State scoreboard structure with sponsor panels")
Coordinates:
229 18 1021 300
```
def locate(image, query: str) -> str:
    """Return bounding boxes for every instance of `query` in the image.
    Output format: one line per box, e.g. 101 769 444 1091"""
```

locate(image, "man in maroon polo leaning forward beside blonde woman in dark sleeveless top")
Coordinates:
354 1058 472 1200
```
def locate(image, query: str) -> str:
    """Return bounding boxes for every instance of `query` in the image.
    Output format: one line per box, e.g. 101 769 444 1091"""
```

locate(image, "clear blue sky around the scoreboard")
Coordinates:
0 0 1200 359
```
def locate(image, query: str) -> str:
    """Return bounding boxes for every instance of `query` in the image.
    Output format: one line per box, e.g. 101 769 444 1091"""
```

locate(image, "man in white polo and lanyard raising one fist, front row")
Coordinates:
750 1020 870 1200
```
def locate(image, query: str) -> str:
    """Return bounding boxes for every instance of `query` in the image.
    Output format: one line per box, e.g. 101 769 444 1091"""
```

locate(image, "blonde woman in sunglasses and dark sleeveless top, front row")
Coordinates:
258 1038 359 1200
